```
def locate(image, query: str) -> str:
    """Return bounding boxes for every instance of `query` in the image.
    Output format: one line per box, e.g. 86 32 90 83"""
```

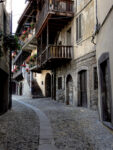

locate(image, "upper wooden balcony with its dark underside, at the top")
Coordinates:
36 0 74 37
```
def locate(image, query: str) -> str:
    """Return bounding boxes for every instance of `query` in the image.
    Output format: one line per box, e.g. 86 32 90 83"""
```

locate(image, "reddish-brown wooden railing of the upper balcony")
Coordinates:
36 0 74 33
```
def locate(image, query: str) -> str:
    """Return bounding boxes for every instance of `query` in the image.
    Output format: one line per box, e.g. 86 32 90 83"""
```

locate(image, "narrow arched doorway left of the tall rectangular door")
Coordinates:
66 75 73 105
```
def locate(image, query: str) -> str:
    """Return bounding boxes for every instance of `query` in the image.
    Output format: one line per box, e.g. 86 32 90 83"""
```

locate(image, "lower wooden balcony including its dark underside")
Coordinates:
37 45 73 70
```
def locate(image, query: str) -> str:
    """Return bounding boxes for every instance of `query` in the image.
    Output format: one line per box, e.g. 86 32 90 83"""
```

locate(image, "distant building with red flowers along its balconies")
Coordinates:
12 0 51 98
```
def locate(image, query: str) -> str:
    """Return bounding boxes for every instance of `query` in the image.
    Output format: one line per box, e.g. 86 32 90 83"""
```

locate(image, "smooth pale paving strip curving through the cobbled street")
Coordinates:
14 99 57 150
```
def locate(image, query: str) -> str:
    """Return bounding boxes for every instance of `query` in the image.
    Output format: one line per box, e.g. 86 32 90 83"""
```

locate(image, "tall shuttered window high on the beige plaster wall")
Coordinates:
76 14 82 42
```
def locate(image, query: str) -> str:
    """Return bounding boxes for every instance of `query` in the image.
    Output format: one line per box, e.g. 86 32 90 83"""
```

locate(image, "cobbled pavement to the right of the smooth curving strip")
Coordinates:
14 96 113 150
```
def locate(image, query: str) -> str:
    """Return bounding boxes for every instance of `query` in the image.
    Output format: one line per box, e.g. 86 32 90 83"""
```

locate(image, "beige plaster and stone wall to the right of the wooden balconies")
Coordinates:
56 0 98 110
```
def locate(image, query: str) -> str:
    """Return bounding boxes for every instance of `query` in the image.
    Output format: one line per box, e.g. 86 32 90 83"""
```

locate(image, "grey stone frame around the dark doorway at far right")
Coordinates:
98 52 113 126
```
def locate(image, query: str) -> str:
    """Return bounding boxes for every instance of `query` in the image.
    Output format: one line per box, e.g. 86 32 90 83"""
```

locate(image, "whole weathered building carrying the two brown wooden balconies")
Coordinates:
12 0 98 110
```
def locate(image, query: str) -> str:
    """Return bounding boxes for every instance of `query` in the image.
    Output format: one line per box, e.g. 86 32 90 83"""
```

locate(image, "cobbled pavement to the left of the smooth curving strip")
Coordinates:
0 101 40 150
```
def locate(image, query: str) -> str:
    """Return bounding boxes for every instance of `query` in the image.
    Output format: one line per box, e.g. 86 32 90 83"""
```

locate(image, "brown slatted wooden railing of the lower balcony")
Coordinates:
37 45 73 67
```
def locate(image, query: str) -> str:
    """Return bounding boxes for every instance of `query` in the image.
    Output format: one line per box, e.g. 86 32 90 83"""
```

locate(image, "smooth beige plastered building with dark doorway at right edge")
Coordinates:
95 0 113 129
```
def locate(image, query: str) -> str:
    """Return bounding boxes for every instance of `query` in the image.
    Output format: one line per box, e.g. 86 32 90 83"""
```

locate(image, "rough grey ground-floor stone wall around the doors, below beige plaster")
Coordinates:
56 51 98 109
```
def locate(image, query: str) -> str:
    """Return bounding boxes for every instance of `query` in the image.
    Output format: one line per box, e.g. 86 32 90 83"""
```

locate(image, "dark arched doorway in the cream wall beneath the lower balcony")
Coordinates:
45 73 51 97
